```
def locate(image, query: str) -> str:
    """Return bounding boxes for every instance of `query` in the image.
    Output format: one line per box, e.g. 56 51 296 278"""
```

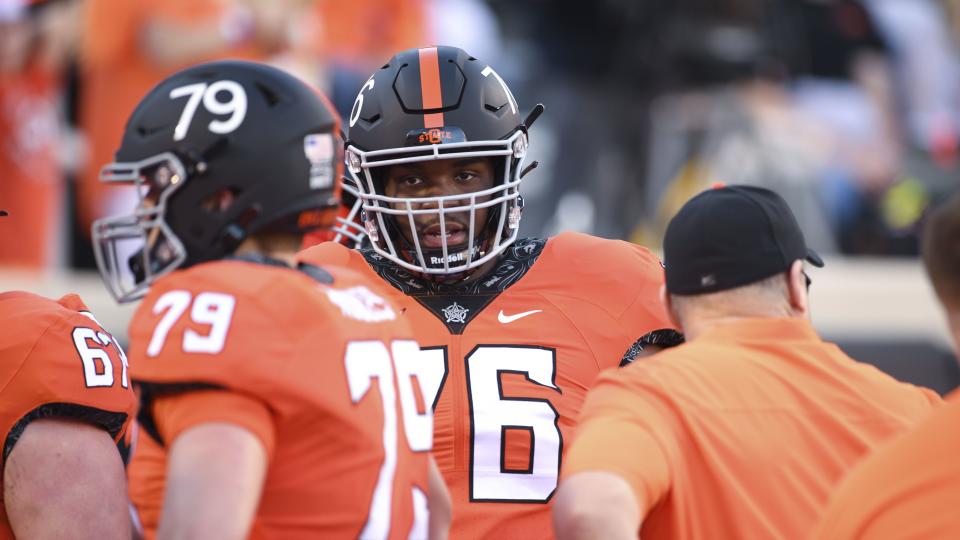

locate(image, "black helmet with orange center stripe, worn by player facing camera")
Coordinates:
344 47 543 278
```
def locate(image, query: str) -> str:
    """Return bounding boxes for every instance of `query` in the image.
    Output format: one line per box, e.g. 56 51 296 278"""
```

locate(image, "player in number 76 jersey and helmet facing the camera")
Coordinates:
301 47 680 538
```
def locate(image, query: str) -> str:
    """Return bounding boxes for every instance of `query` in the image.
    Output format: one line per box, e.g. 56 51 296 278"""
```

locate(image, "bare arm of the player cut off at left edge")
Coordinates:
3 418 131 540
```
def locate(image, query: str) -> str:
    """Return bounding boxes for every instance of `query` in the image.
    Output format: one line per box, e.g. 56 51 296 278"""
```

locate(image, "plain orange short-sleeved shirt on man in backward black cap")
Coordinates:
564 319 940 539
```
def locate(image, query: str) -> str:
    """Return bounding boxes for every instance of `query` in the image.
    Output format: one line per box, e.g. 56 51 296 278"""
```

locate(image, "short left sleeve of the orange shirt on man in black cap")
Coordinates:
561 372 671 515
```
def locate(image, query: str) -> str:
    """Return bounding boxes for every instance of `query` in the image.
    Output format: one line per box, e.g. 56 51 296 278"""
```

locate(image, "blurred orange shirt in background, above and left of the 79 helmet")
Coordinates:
77 0 263 232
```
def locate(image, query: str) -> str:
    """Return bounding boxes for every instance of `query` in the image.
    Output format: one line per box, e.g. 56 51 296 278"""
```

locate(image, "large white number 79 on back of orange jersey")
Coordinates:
344 340 433 539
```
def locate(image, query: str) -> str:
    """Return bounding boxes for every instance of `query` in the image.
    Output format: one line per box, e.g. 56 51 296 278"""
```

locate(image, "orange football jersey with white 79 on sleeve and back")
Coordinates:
130 258 432 539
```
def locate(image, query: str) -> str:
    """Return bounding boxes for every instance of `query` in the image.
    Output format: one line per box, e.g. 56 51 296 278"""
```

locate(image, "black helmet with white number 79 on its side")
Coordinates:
93 61 343 302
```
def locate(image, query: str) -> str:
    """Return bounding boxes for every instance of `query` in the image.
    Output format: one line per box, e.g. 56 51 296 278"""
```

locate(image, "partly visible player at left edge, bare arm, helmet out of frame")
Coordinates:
0 286 137 539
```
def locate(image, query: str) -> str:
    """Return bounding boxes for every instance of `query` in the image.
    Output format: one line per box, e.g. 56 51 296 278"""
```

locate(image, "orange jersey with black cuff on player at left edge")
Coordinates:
0 292 137 538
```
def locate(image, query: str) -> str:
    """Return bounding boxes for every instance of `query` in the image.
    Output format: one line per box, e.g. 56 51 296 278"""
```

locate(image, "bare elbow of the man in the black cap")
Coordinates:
553 471 640 540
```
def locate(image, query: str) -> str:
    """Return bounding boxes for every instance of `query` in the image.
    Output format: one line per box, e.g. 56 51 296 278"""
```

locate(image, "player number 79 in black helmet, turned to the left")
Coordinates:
93 61 449 538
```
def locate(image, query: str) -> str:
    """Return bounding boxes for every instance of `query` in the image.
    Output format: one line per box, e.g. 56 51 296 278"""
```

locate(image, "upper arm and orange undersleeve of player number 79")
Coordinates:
152 390 275 539
